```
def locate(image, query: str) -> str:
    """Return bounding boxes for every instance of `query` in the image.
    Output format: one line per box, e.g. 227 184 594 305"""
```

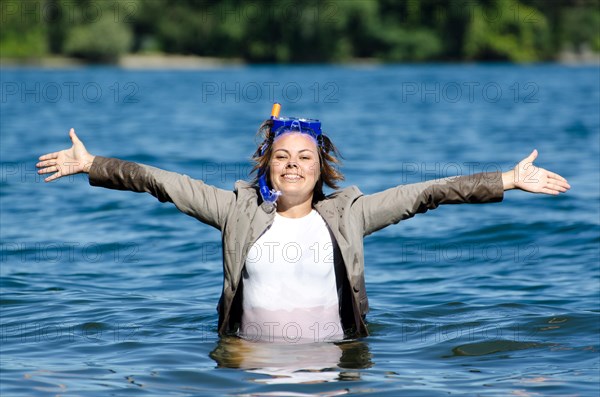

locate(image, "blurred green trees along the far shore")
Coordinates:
0 0 600 63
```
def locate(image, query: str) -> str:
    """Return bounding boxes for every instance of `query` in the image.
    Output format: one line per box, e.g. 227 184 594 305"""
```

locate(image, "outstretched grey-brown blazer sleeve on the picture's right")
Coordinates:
352 172 504 236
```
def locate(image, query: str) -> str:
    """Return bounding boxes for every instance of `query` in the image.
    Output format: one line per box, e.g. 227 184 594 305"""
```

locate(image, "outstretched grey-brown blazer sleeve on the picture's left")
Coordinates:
89 156 235 230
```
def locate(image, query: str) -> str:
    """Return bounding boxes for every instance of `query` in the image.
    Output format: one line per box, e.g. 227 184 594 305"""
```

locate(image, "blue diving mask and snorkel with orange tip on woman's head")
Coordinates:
258 103 323 206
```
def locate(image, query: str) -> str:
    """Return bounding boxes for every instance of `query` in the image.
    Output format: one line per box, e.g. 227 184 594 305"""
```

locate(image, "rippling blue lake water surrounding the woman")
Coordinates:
0 65 600 397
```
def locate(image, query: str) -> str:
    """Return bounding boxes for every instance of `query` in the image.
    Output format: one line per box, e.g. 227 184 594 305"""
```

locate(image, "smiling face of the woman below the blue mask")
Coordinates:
270 133 320 200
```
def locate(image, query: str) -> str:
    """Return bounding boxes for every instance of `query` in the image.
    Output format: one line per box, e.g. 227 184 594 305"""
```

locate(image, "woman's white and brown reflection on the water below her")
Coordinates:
210 336 373 384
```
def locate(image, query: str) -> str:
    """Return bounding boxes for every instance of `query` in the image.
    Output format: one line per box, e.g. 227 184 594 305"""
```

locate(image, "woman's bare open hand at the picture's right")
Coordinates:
502 150 571 195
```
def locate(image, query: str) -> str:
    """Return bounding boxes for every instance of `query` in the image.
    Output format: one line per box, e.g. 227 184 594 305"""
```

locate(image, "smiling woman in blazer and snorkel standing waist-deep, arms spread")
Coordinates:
37 104 570 342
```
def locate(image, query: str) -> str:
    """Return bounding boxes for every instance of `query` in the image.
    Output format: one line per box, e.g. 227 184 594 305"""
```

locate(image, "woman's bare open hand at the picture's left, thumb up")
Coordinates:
36 128 95 182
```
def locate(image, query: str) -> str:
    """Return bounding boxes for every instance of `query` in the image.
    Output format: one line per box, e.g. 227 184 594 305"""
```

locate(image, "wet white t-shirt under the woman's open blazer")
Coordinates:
240 210 344 343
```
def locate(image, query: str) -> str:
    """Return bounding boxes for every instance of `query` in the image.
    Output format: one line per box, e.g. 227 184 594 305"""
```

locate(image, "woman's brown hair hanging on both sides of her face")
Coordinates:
250 120 344 202
